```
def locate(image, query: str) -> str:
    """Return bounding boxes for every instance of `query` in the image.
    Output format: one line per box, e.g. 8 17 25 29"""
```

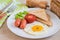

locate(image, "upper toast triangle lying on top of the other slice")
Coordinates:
29 9 48 21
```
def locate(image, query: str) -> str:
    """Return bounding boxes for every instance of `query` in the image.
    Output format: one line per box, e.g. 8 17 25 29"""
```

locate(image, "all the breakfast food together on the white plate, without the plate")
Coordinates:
14 9 52 35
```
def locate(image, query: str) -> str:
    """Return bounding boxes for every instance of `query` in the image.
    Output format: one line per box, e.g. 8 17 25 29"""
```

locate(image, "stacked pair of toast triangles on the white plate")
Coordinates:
29 9 52 26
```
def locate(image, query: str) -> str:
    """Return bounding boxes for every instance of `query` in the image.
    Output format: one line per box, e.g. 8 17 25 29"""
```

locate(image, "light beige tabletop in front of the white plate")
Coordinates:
0 21 60 40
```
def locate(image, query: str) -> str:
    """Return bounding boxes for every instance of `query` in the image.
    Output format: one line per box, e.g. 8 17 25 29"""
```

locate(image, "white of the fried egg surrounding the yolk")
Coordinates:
24 21 49 36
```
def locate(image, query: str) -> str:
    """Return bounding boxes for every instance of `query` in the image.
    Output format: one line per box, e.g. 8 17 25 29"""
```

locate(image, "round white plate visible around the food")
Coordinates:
7 8 60 39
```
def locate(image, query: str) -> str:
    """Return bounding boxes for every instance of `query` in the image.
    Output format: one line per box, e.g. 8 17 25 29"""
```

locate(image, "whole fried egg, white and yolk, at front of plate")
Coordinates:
24 22 49 36
